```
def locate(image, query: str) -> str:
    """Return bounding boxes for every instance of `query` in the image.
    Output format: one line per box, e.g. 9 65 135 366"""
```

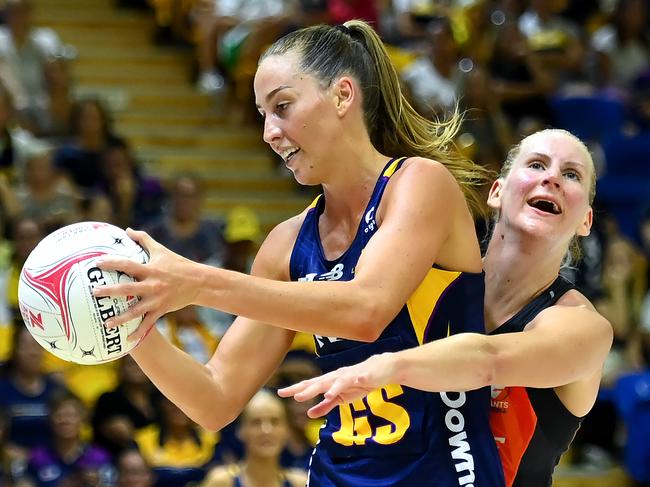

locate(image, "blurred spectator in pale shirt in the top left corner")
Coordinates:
0 0 69 134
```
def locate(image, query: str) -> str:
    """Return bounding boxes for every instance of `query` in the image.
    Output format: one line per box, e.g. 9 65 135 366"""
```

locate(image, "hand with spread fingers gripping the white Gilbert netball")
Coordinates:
94 229 199 341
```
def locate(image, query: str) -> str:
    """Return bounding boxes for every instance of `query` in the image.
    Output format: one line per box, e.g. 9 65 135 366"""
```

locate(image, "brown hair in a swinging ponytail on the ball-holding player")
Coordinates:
260 20 492 214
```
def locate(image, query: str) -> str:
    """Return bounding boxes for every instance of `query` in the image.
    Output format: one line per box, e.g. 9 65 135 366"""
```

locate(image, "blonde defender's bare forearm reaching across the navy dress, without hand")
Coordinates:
386 333 496 392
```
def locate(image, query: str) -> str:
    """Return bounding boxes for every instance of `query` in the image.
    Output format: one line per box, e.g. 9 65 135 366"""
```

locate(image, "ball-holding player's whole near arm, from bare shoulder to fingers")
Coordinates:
100 159 460 341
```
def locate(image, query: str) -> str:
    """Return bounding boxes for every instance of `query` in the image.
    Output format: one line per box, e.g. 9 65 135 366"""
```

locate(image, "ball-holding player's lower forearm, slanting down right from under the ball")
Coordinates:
131 328 233 430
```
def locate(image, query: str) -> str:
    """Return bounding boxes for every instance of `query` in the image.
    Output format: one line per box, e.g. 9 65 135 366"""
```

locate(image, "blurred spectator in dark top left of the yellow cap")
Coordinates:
148 174 225 266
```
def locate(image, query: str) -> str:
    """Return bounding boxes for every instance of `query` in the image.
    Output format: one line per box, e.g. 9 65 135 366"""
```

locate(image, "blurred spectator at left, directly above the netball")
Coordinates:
16 150 79 234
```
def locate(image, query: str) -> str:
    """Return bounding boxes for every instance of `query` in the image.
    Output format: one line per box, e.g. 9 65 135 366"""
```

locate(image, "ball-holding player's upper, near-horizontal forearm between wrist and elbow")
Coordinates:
195 266 382 341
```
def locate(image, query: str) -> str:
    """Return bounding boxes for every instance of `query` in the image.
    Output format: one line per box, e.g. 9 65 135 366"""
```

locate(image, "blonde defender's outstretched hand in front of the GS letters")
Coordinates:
278 353 393 418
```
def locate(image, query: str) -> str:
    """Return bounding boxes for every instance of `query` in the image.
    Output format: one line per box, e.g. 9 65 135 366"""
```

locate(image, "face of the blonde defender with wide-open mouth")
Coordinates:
488 131 594 244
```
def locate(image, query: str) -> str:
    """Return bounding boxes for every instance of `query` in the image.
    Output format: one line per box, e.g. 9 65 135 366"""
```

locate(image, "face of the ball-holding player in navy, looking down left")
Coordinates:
254 53 338 184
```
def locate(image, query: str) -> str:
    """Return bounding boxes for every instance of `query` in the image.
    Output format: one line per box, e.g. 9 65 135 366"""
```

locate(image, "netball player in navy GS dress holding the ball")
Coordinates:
93 21 503 487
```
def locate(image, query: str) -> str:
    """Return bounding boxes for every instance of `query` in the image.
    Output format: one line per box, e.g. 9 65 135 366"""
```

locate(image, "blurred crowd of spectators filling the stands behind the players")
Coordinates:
0 0 650 487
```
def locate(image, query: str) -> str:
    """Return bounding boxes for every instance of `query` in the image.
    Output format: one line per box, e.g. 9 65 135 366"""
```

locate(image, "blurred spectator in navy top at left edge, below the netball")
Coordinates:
0 325 63 449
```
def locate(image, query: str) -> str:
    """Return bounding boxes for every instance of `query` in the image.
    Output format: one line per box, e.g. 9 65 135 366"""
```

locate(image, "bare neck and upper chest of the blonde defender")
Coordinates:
483 223 564 331
